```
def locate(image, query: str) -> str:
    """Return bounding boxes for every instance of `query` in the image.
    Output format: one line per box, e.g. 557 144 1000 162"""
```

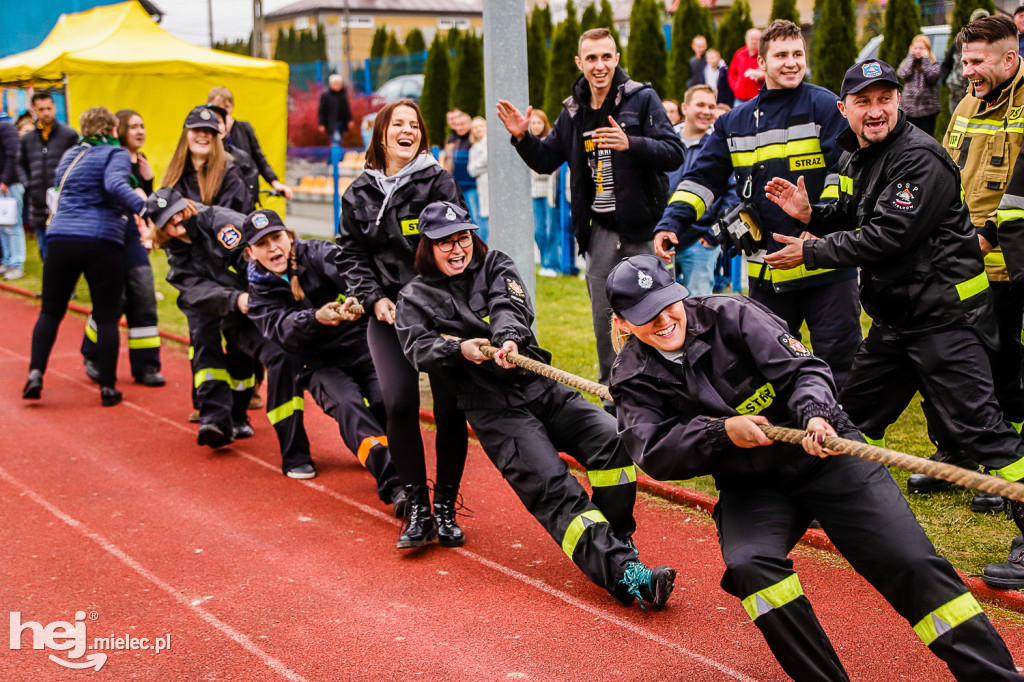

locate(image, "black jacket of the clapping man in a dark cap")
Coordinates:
804 112 995 343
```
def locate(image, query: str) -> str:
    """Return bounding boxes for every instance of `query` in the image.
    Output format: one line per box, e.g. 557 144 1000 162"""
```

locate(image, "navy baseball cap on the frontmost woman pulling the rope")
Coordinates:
604 254 690 326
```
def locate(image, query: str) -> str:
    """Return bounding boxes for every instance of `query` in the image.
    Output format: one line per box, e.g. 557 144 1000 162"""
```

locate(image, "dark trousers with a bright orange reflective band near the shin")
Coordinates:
301 355 398 503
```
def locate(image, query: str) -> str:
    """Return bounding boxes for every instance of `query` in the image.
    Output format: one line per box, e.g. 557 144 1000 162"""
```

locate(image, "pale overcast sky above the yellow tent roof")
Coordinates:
155 0 294 47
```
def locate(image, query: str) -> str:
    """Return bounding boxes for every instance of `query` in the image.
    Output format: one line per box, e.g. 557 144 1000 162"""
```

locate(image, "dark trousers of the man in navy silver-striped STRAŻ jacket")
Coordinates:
750 278 862 388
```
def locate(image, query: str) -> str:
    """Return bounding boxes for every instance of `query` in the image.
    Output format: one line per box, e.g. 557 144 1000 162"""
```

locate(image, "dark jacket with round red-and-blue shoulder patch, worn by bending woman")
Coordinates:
164 204 249 327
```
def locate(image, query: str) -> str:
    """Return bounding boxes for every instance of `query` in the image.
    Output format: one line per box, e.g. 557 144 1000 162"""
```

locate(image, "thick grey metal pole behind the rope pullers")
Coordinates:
483 0 537 299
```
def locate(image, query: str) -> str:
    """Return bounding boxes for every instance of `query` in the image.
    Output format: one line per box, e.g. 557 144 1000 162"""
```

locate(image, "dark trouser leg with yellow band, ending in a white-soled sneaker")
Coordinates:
224 321 312 472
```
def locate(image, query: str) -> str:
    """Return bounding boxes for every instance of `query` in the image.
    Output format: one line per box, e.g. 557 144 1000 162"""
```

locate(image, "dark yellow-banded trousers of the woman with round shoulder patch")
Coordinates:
182 307 255 429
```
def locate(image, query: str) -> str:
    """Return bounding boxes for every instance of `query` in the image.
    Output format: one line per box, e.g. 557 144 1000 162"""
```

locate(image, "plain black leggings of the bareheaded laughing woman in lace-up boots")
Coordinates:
367 316 469 487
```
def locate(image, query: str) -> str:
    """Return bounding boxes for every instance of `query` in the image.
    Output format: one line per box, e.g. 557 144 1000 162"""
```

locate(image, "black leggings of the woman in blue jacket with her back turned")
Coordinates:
29 239 125 386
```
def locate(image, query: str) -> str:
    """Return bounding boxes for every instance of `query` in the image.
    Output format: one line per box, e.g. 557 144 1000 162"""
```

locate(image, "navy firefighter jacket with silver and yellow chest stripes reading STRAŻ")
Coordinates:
655 83 856 291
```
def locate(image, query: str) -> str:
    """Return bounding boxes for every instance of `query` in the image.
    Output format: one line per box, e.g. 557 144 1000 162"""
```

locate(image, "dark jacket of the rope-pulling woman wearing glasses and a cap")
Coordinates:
394 251 554 410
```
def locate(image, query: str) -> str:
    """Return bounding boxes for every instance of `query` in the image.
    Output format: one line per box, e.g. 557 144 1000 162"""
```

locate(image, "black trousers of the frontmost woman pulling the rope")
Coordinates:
715 446 1022 682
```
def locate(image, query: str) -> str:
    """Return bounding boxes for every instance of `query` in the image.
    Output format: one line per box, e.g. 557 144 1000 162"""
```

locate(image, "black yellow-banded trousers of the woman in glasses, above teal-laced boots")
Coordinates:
466 379 637 591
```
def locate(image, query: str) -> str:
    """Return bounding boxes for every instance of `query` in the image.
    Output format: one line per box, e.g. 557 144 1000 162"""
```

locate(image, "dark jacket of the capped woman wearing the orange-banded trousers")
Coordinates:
249 235 370 358
